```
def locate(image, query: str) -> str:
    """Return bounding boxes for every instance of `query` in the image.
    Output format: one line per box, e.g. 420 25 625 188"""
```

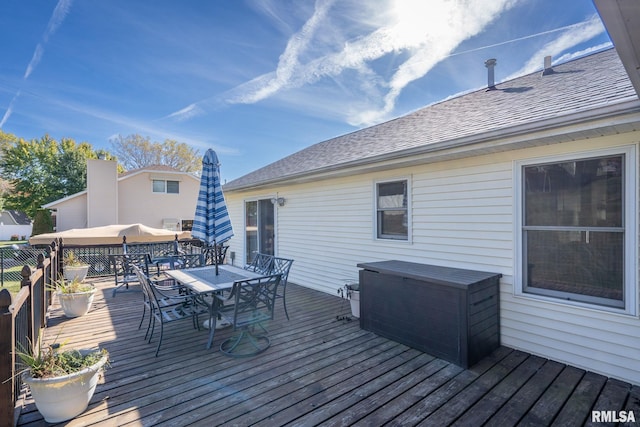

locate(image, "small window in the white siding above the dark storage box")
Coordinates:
376 180 409 240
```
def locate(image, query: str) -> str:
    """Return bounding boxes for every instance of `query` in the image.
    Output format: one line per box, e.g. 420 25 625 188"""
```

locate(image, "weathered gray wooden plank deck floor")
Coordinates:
19 280 640 427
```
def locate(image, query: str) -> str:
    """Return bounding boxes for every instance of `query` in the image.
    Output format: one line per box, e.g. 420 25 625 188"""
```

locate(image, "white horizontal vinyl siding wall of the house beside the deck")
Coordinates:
226 133 640 384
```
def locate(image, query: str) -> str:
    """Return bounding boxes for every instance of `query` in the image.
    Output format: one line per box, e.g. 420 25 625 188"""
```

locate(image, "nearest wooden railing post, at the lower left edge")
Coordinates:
0 289 16 425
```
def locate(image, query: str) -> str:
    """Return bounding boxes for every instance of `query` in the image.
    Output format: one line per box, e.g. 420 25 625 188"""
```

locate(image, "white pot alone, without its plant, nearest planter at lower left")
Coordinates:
23 356 107 423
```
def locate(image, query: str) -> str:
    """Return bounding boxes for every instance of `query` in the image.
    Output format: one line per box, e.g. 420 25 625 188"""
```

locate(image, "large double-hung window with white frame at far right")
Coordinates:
518 148 636 311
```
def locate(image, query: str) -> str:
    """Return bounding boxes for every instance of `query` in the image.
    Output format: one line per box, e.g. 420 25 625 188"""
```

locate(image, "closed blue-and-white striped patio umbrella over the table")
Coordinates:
191 149 233 274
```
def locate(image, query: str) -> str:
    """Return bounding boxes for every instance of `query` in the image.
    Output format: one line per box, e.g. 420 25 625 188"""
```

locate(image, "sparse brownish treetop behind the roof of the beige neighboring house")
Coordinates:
110 134 202 172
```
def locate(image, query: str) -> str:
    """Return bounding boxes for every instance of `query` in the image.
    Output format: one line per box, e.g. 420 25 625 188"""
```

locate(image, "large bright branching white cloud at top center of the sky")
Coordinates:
222 0 514 125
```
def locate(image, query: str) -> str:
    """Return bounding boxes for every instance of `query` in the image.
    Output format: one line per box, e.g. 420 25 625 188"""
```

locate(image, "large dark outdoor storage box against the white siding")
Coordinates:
358 261 502 368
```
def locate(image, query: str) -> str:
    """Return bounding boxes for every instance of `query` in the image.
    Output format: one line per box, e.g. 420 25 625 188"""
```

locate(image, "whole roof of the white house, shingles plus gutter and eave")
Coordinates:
224 49 640 191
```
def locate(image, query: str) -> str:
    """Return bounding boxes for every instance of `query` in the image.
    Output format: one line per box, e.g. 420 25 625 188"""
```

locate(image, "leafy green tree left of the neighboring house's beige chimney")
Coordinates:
0 135 105 218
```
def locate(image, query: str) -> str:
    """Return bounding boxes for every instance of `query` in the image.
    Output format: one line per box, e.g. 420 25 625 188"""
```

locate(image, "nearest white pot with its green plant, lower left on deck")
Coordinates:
16 338 109 423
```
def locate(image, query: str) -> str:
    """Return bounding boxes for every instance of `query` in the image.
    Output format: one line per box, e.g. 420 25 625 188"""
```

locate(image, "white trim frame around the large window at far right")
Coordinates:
513 145 638 316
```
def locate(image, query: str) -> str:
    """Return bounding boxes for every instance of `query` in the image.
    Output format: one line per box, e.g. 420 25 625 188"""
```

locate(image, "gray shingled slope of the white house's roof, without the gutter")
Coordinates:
224 49 637 190
